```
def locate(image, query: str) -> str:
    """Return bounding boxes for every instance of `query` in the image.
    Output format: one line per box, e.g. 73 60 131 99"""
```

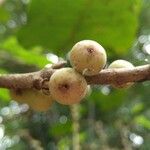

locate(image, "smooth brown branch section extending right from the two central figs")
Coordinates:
86 65 150 84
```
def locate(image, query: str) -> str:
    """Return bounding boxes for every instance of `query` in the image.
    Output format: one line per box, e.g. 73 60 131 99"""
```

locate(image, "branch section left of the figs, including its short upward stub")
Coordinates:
0 61 66 89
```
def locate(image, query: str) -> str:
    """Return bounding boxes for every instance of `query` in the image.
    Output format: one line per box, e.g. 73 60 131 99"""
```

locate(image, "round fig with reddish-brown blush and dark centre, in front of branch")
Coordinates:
49 68 87 105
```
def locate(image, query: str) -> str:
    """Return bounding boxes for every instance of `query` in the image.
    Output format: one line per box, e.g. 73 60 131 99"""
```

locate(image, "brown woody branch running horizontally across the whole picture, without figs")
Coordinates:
0 62 150 89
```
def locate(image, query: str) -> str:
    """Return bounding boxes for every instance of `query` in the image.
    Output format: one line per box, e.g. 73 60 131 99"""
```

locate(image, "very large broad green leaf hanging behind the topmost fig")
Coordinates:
17 0 141 55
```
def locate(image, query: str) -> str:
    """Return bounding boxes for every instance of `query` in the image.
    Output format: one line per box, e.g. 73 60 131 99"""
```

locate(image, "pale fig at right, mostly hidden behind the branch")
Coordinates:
108 59 134 88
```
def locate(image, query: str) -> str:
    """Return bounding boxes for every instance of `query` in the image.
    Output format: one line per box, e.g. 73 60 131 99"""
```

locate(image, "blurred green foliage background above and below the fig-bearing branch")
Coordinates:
0 0 150 150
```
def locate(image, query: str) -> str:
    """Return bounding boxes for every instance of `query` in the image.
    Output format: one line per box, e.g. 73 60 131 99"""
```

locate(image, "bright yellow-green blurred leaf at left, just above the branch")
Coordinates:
0 37 50 68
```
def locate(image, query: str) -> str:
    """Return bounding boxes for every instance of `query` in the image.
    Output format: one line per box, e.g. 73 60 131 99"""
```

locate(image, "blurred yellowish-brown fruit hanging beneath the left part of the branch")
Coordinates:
10 89 53 111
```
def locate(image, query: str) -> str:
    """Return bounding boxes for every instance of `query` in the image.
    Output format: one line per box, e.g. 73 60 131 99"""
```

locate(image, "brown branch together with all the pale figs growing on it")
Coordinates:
0 40 150 111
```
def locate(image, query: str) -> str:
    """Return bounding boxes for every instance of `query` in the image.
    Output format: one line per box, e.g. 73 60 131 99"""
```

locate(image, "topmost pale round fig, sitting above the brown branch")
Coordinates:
69 40 107 76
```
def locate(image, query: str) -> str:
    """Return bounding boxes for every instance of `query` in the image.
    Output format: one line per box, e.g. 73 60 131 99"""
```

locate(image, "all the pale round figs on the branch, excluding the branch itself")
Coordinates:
10 40 134 111
